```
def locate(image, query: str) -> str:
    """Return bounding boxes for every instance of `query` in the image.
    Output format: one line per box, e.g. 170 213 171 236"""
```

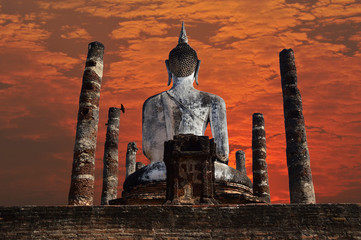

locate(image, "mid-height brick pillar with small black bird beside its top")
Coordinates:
101 107 120 205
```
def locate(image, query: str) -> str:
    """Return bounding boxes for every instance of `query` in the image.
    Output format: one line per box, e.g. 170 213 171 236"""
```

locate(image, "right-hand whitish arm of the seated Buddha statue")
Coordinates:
209 96 229 163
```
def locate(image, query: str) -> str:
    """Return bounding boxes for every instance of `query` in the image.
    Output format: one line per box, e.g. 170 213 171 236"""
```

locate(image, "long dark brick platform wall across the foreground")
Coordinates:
0 204 361 240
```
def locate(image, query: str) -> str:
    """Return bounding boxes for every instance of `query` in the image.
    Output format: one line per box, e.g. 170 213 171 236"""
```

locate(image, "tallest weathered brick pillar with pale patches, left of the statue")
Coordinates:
68 42 104 205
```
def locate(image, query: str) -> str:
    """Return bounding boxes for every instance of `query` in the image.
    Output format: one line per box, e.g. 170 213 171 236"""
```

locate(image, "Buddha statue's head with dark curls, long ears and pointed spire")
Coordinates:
165 22 201 86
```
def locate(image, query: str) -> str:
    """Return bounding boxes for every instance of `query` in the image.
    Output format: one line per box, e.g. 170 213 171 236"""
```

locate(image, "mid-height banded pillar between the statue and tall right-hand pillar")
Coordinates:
252 113 271 202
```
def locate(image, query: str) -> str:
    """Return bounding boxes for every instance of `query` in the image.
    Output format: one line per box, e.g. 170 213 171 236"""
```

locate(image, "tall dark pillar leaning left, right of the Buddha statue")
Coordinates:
280 49 316 203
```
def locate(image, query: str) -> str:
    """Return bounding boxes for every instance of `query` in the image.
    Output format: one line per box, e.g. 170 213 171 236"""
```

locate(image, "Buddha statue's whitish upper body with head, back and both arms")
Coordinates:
143 24 229 163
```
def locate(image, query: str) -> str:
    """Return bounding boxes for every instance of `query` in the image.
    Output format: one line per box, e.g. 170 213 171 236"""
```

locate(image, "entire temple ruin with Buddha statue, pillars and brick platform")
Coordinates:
0 21 361 240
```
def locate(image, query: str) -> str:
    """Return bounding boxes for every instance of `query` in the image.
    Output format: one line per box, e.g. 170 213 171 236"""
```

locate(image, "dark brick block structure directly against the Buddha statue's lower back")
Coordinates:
164 134 217 205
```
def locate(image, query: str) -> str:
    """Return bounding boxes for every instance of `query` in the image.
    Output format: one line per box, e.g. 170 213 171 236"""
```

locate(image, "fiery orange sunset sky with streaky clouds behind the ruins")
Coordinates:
0 0 361 206
